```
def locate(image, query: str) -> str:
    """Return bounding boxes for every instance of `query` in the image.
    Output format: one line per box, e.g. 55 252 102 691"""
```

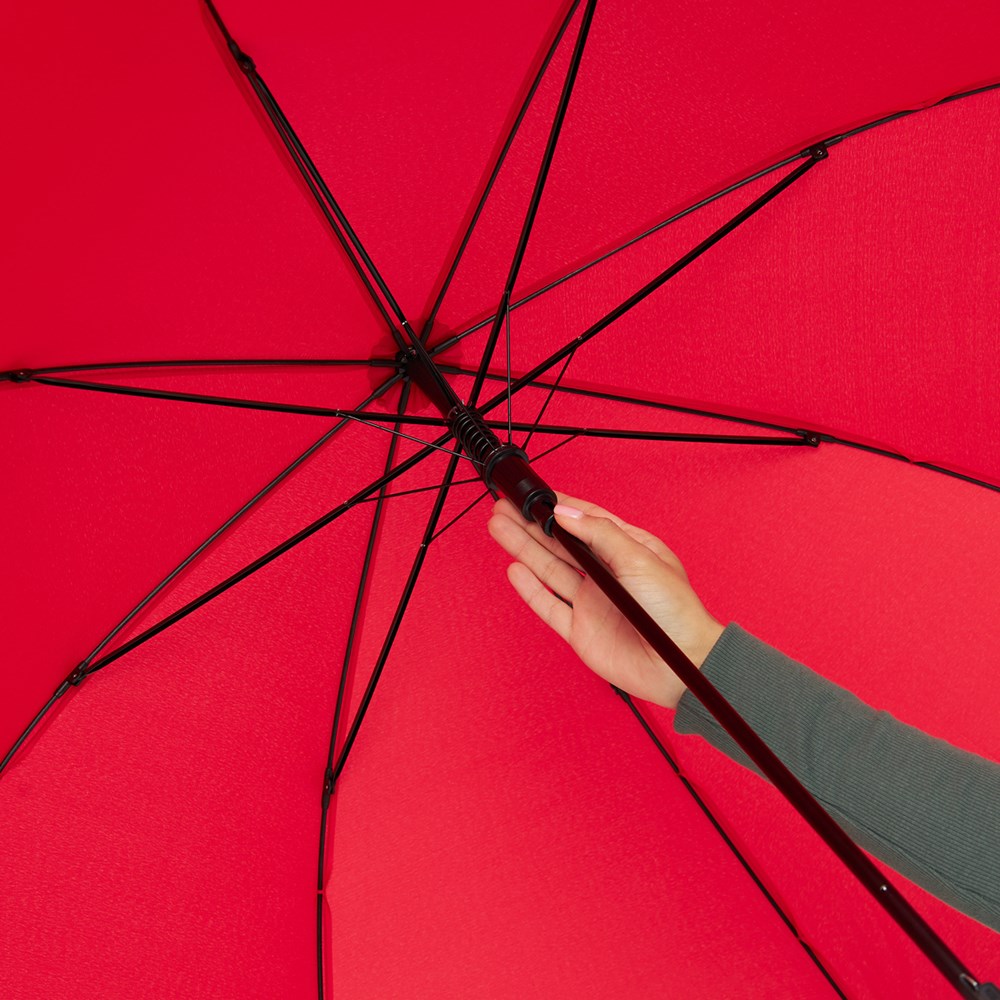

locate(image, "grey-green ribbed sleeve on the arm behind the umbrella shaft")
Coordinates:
674 625 1000 931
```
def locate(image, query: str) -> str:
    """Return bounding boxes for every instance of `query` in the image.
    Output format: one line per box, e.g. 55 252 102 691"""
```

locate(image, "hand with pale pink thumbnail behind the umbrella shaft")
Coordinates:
489 494 723 708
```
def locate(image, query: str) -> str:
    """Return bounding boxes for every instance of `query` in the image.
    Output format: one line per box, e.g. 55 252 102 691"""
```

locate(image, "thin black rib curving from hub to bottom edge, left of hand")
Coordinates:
316 383 410 1000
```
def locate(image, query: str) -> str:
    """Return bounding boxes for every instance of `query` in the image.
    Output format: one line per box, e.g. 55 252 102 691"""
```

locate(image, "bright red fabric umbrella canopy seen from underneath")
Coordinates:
0 0 1000 998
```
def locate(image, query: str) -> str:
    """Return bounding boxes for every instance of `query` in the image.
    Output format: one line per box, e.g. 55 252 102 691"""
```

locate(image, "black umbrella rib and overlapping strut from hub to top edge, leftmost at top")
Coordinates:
205 0 406 349
